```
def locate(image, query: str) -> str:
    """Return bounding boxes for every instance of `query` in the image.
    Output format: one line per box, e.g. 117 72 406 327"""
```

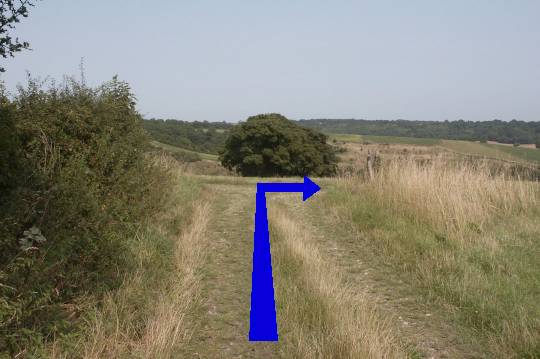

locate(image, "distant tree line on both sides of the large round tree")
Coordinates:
143 119 540 154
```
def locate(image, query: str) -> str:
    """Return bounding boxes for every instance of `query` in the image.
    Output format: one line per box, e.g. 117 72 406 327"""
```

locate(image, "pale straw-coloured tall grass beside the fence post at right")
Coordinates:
368 157 540 239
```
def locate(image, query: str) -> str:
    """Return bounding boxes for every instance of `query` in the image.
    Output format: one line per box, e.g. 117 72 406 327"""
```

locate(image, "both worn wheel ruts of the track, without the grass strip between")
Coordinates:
181 183 485 358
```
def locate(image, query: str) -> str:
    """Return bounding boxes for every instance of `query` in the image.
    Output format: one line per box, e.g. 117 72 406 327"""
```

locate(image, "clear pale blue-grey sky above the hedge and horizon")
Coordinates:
0 0 540 122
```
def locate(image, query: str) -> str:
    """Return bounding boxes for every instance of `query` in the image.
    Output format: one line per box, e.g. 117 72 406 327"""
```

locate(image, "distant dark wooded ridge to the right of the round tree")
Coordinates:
298 119 540 147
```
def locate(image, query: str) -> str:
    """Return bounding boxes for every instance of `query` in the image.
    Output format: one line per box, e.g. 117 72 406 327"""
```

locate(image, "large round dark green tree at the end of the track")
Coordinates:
220 113 336 177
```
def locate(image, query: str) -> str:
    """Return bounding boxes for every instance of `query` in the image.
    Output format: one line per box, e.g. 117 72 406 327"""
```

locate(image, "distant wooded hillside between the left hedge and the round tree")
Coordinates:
143 119 233 154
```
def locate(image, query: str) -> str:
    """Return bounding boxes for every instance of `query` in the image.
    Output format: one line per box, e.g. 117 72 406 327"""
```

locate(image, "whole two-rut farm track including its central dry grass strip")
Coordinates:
182 177 490 358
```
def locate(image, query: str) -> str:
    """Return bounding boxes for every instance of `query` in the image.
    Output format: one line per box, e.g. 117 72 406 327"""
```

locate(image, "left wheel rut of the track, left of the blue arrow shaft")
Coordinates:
187 184 276 358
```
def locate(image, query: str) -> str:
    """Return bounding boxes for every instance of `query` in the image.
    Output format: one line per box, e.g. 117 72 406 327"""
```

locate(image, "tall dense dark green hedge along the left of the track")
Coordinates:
0 78 169 355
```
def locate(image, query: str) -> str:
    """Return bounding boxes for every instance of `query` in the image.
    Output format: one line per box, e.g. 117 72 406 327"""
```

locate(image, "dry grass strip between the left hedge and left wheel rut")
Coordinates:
83 202 209 359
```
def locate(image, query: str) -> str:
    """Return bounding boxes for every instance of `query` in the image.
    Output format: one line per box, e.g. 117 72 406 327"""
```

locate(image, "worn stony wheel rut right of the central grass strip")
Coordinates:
270 194 483 358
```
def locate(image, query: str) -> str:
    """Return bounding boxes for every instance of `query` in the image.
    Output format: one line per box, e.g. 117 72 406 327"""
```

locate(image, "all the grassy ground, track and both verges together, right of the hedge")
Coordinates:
37 136 540 358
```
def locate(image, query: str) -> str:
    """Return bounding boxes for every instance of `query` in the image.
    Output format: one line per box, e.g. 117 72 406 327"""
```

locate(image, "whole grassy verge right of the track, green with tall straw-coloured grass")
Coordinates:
323 163 540 358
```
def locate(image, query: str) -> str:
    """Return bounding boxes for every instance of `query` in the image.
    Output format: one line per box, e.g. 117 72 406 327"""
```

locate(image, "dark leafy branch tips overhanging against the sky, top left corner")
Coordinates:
0 0 34 72
